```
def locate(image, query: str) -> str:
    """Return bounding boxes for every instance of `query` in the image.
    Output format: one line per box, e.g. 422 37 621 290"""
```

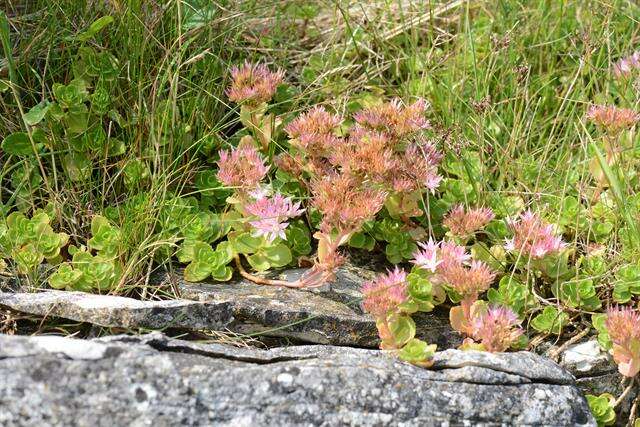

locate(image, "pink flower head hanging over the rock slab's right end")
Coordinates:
362 267 408 317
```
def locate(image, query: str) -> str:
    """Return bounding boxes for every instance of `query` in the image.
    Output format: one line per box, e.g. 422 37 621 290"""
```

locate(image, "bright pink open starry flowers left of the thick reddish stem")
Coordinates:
245 194 304 242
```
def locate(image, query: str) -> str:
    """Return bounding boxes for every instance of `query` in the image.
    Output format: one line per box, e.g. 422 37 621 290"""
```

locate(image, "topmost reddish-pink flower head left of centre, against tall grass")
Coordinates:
227 62 284 106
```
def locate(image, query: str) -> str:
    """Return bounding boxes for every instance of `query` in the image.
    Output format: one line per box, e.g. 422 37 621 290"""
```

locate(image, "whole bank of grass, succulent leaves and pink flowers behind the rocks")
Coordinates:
0 0 640 423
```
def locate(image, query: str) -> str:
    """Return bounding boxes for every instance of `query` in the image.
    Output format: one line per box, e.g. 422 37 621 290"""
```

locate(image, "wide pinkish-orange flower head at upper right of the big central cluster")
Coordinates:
354 98 430 138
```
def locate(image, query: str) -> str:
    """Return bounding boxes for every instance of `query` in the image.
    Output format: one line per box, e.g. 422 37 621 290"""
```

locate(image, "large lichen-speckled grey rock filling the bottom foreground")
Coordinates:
0 333 595 427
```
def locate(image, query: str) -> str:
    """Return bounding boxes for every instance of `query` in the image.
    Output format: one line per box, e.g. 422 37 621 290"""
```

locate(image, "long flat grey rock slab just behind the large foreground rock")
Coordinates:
0 267 460 348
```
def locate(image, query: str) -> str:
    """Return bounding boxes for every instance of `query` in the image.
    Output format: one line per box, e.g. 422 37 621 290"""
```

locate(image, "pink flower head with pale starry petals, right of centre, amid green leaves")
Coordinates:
505 210 565 259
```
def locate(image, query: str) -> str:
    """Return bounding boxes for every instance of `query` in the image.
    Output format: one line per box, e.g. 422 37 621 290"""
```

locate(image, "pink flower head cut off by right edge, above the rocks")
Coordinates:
605 307 640 377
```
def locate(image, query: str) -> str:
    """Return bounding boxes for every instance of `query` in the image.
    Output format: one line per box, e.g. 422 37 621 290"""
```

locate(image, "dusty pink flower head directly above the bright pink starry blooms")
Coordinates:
218 144 269 191
